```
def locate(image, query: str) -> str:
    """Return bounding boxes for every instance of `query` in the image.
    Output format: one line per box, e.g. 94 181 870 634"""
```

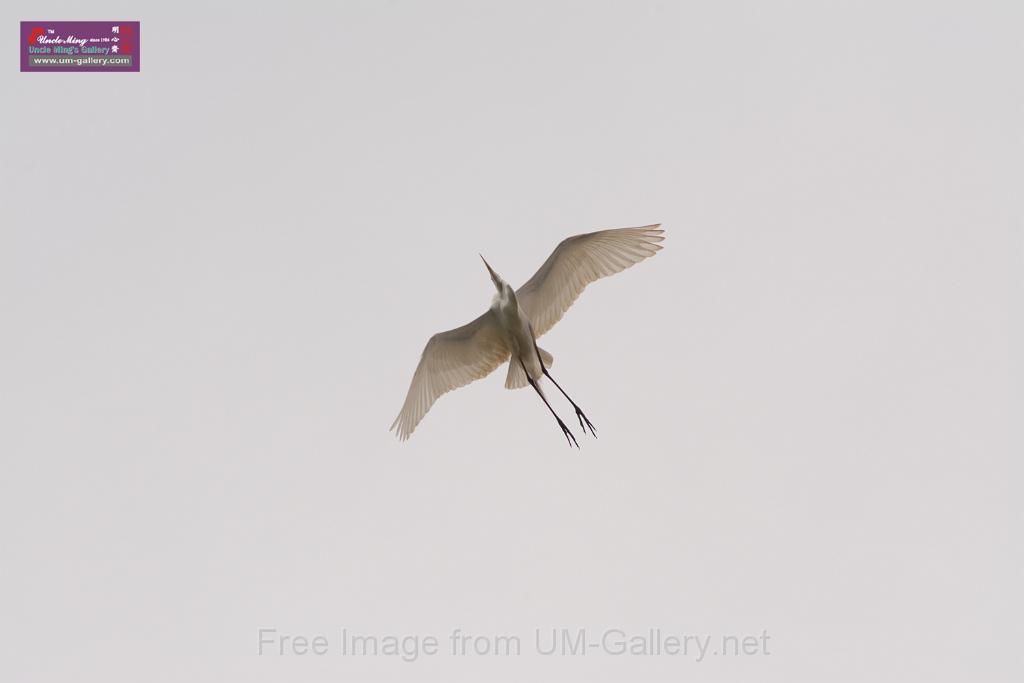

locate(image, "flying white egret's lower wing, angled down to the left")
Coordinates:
391 310 510 441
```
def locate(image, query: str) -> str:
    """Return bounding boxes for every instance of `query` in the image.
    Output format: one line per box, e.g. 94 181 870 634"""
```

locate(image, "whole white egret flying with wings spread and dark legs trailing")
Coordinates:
390 223 665 449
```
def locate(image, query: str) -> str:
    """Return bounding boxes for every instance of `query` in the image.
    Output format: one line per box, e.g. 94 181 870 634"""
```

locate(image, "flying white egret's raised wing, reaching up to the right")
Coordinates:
515 225 665 337
